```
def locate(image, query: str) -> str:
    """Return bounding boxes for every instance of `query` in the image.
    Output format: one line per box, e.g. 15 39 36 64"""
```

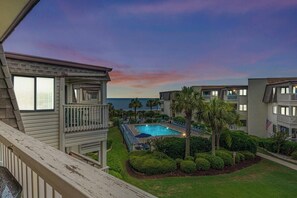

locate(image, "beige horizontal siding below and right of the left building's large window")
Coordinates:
21 78 60 148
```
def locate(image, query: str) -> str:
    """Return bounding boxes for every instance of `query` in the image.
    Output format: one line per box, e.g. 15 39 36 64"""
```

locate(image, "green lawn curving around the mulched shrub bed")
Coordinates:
107 128 297 198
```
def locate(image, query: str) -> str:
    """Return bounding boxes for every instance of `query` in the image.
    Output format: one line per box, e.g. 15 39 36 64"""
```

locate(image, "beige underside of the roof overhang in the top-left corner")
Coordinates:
0 0 39 44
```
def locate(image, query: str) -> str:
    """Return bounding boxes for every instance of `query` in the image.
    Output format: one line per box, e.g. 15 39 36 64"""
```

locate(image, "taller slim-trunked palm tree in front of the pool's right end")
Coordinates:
172 87 204 157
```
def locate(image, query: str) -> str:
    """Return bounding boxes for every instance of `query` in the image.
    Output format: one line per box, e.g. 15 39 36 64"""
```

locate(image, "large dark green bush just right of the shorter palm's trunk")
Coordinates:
220 130 257 153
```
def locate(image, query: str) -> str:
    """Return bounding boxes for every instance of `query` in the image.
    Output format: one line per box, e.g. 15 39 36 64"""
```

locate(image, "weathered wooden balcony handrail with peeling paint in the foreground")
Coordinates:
0 121 154 198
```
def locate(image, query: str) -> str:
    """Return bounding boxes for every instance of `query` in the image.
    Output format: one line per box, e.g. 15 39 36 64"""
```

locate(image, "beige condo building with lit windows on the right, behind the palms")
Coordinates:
160 78 297 139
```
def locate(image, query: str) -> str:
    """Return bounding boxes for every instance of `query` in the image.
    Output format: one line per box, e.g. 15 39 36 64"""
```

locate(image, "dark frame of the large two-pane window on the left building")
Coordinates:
12 75 56 112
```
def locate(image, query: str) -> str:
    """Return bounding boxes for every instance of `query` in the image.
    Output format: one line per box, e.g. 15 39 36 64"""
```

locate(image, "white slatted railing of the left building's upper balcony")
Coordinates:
64 104 108 133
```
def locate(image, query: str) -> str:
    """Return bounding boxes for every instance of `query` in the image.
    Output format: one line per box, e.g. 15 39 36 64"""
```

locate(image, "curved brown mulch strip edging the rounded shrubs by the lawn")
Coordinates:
126 156 262 179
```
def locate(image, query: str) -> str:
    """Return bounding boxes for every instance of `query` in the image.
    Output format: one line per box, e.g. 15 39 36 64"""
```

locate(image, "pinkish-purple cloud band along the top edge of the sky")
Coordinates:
119 0 297 14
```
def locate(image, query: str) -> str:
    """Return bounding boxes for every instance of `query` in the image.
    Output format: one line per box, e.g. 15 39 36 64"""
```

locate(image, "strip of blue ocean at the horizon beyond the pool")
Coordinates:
107 98 160 111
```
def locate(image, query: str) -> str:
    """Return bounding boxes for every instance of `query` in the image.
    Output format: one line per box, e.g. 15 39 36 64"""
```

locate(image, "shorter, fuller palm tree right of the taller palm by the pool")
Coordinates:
200 98 239 155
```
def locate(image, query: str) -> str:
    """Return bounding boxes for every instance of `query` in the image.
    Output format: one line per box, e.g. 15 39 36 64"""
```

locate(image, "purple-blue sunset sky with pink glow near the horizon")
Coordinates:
4 0 297 98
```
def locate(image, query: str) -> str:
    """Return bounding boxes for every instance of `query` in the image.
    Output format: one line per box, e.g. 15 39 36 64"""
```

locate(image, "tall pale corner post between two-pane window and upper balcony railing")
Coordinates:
59 77 65 152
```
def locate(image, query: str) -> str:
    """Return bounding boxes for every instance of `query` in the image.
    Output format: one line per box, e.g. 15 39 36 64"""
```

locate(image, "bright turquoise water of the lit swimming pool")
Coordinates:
135 125 180 136
